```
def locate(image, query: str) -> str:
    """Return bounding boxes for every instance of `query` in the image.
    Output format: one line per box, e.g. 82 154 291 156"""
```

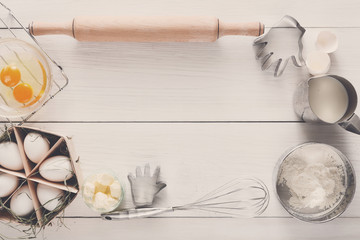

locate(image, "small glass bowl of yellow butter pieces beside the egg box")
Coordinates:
81 170 125 213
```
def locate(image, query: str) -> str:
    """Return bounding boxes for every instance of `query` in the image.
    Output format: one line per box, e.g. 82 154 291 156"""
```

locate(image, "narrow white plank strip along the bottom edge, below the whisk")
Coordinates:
4 218 360 240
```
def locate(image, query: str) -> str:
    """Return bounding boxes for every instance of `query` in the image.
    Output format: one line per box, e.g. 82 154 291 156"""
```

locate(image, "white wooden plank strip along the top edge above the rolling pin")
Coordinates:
3 0 360 28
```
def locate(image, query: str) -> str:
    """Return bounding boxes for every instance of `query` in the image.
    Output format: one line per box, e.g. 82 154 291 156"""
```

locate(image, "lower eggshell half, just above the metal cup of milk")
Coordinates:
306 51 331 75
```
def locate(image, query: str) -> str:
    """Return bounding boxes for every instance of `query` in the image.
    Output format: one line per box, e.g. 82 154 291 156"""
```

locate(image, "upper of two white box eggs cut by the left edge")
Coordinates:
0 142 24 171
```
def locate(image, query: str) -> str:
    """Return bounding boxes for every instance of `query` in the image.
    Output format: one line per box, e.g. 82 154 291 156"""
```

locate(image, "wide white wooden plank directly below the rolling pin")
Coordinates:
7 28 360 121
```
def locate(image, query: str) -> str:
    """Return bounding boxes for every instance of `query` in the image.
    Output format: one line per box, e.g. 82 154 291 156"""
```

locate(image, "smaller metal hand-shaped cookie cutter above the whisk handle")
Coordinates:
128 164 166 207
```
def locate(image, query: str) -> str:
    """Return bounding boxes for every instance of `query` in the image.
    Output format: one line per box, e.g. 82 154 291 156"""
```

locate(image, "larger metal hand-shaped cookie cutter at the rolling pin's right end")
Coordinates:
253 15 305 77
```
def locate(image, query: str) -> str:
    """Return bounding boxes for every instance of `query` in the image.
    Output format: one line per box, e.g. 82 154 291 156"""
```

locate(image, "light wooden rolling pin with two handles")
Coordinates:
29 16 264 42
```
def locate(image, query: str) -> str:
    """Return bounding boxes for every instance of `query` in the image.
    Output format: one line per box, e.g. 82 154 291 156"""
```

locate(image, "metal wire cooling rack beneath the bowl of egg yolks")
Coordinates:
0 2 69 133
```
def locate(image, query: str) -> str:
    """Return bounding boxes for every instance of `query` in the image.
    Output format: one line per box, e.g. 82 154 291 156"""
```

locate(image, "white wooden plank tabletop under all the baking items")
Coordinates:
0 0 360 240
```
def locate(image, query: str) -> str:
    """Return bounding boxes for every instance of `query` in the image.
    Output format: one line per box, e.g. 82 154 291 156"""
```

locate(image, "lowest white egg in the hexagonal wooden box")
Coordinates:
10 185 34 217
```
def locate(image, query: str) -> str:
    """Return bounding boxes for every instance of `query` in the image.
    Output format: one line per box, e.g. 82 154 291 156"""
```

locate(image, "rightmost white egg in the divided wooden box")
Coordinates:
39 156 74 182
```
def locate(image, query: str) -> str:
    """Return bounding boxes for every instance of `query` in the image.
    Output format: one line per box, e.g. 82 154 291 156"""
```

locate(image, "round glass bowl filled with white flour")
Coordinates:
274 142 356 223
